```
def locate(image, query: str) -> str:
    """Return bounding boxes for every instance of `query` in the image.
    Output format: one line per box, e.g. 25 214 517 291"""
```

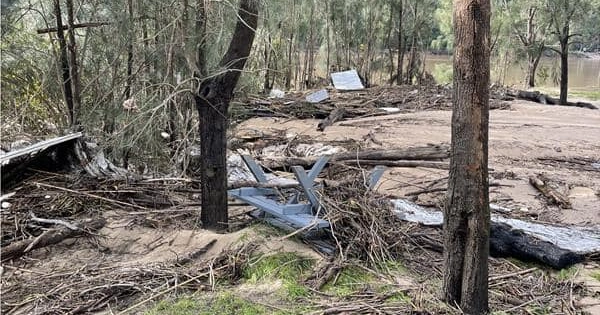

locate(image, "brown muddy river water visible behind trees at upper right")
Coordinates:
426 55 600 91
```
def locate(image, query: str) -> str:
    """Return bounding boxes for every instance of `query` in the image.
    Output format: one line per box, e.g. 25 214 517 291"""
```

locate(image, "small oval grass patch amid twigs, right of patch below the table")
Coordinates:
323 266 373 296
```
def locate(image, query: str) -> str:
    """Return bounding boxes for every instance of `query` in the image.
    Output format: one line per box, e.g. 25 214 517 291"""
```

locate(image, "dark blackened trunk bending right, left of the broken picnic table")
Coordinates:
195 0 258 231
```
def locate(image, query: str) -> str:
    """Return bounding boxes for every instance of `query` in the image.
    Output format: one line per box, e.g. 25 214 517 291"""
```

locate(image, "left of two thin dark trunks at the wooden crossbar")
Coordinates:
54 0 75 126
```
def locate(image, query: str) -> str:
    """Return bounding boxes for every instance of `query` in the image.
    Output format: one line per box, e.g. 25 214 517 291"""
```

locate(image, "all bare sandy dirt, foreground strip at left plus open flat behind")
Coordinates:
2 97 600 314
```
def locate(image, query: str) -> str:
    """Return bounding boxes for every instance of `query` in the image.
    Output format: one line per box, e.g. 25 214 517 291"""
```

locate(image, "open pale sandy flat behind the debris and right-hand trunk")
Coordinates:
238 101 600 228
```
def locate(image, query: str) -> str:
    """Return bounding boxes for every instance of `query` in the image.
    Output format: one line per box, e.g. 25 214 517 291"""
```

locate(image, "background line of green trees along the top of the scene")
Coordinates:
1 0 600 171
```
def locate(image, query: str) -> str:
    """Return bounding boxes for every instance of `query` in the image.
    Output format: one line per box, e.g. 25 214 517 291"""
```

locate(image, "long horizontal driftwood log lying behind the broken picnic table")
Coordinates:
262 145 450 169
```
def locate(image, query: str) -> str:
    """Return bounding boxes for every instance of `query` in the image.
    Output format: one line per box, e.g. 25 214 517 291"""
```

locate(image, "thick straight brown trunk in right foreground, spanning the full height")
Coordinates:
443 0 490 314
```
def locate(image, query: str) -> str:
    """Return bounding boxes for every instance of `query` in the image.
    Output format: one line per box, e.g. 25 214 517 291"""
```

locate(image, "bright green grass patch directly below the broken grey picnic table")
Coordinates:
242 252 315 299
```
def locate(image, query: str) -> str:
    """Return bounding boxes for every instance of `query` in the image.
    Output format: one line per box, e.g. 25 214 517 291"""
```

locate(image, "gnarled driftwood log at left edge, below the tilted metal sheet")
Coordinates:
2 219 106 262
